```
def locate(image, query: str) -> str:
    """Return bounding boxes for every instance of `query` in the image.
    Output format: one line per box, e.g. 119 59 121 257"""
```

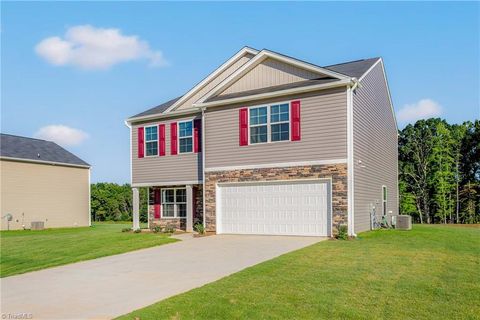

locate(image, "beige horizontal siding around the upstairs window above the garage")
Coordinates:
205 88 347 168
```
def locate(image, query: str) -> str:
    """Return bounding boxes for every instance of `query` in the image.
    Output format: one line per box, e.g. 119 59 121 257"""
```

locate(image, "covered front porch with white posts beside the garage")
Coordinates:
132 184 203 232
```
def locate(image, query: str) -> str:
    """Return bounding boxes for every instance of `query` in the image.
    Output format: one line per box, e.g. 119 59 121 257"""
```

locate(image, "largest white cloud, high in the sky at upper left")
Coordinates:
35 25 167 69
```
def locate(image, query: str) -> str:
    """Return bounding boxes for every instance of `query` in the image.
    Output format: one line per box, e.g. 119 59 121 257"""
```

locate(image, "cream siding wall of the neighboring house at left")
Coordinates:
0 160 90 230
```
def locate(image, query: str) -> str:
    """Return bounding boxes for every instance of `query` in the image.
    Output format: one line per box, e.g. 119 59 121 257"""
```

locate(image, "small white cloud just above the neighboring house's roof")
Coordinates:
34 124 88 146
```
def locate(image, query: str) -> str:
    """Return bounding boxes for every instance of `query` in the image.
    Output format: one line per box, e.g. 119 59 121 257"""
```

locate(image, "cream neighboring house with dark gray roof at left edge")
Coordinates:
0 134 90 230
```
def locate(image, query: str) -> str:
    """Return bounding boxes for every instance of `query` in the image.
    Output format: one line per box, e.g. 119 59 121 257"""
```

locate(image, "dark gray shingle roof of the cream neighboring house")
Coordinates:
0 133 90 166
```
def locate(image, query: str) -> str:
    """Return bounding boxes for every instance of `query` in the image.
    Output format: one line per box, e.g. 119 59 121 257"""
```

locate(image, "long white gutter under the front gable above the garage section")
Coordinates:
193 78 353 108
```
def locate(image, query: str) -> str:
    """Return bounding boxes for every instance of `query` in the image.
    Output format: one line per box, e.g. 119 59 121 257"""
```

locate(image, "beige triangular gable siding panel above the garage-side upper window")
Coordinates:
220 58 322 95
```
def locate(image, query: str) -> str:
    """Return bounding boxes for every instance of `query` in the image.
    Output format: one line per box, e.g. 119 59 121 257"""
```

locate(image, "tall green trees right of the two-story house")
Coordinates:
398 118 480 223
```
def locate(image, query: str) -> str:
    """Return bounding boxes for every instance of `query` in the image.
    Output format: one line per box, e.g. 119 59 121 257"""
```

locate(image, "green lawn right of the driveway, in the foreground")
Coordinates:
117 225 480 320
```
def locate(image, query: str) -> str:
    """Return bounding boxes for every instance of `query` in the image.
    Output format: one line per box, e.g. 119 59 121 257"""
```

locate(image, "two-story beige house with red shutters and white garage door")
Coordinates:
126 47 398 236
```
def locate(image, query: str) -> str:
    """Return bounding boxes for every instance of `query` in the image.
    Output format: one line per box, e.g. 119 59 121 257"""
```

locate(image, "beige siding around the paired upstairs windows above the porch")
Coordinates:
132 115 202 185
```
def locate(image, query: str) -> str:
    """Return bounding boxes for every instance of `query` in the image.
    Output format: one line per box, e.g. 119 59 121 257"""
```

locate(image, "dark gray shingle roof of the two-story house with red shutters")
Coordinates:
131 54 380 118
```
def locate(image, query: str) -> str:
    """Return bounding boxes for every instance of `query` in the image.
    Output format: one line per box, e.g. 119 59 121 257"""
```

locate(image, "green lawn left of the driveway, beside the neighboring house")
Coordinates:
0 223 176 277
